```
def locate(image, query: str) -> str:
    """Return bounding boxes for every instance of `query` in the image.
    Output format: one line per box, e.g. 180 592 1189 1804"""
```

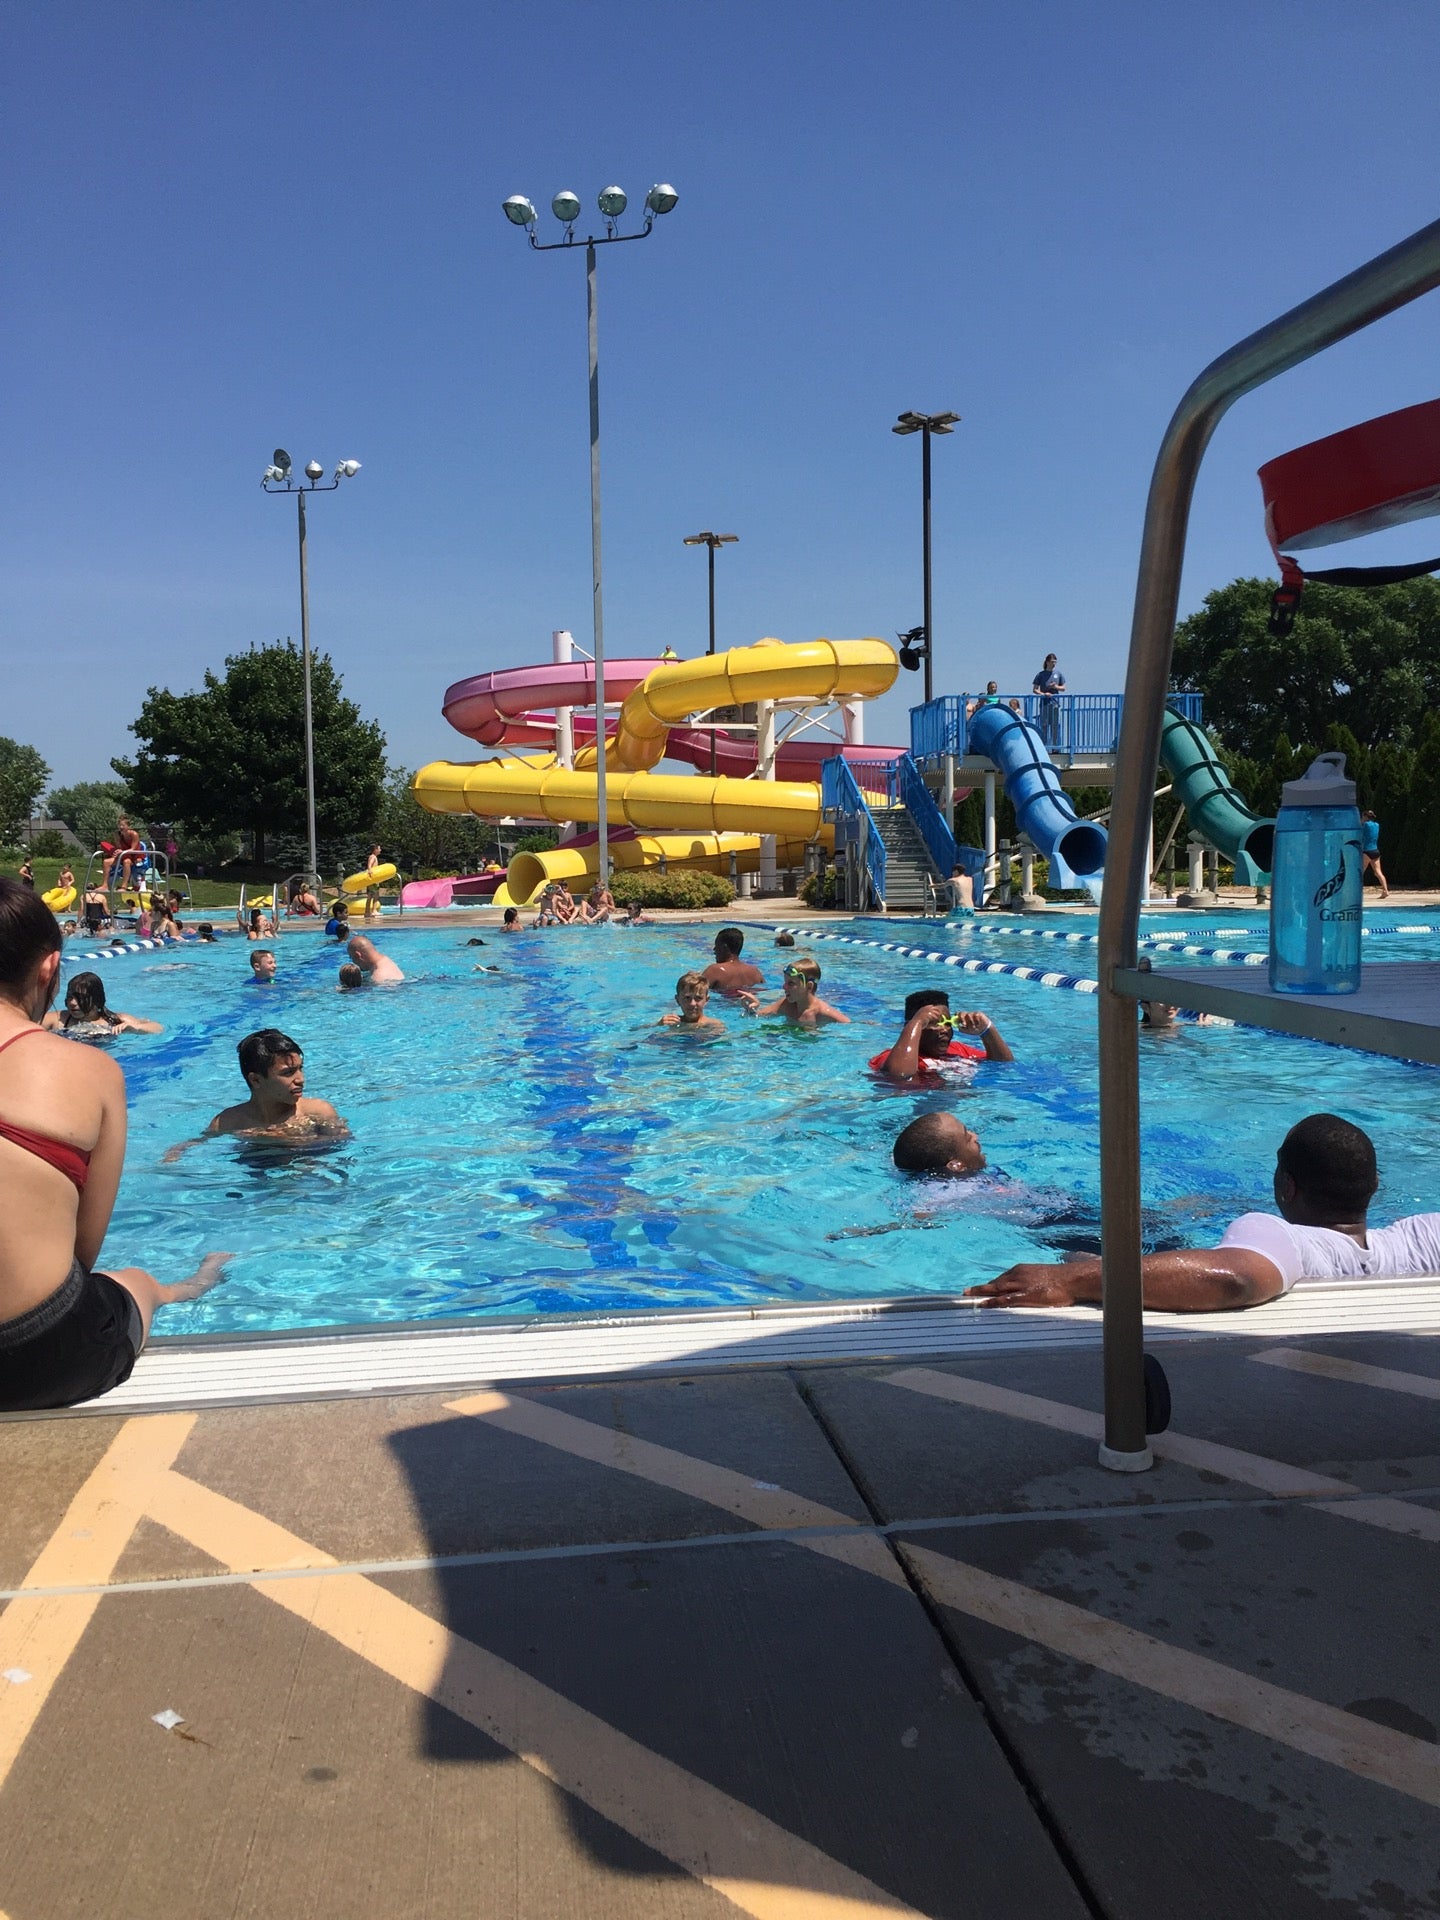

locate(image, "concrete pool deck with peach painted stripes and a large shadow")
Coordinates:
0 1315 1440 1920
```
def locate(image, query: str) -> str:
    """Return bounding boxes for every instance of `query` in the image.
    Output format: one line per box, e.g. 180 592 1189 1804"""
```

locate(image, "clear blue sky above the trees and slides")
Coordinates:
0 0 1440 780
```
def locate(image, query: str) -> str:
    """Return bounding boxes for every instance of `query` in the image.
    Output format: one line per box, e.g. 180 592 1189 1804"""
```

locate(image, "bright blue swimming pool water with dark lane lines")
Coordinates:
71 914 1440 1334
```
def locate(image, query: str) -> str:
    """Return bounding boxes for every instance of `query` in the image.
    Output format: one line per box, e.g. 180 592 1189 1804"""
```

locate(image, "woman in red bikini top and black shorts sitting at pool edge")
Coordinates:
0 879 230 1413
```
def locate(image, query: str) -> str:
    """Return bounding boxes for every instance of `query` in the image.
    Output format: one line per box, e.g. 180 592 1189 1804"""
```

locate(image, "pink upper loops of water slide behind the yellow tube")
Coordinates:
442 660 904 780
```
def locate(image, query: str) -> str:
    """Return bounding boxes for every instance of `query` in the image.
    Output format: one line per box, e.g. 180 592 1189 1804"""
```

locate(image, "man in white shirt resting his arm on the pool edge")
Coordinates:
972 1114 1440 1313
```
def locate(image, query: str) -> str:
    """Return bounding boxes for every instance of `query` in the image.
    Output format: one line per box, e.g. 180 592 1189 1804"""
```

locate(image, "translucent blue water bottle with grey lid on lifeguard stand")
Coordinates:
1269 753 1365 993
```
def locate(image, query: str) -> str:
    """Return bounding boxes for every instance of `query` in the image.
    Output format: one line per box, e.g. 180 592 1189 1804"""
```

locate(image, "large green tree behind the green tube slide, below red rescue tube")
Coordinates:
1175 578 1440 760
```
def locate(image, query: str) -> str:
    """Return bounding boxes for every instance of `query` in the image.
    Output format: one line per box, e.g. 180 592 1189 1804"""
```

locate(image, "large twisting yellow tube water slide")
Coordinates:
415 639 899 902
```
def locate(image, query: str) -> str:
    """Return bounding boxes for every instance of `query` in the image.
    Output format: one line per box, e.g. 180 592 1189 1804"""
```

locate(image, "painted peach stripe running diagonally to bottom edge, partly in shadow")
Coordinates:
150 1473 916 1920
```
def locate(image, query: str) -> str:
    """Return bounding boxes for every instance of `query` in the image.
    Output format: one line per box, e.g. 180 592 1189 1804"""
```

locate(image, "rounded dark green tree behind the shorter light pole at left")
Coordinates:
111 641 384 862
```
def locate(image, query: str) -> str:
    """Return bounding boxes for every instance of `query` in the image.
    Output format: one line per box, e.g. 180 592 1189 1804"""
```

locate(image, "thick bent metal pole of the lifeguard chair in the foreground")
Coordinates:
1096 221 1440 1473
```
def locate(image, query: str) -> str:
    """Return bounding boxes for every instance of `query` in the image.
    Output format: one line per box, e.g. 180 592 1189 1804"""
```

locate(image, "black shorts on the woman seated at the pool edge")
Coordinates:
0 1260 144 1413
